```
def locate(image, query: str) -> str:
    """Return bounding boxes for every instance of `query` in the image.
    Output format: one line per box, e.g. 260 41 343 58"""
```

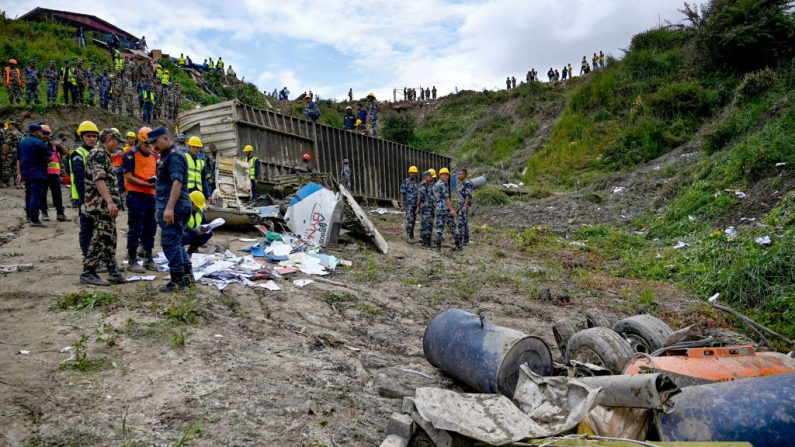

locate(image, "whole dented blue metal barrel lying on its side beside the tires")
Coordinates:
422 308 552 398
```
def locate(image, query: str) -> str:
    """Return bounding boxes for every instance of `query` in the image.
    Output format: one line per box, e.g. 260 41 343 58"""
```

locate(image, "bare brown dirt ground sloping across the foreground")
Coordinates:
0 189 704 446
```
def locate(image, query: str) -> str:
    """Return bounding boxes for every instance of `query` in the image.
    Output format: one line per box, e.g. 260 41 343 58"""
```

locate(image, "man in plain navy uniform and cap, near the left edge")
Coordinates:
18 124 52 227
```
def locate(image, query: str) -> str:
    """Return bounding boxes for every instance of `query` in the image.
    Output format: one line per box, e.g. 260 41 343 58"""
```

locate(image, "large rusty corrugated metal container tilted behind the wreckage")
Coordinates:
179 101 450 200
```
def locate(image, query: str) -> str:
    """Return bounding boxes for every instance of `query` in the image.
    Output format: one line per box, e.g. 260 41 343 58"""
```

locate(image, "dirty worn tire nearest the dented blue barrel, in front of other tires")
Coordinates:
566 327 634 374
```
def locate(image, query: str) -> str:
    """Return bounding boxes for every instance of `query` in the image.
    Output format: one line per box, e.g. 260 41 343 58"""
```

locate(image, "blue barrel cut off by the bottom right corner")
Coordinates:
657 374 795 447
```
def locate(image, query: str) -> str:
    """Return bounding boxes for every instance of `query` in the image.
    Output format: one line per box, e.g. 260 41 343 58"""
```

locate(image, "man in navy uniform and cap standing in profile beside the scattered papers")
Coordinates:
147 126 194 292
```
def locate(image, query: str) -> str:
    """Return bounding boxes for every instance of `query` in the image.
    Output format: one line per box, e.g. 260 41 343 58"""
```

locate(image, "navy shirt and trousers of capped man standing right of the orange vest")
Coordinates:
155 144 193 284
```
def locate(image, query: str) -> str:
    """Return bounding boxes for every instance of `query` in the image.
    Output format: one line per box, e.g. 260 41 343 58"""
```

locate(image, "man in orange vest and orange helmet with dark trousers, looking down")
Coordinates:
122 127 157 273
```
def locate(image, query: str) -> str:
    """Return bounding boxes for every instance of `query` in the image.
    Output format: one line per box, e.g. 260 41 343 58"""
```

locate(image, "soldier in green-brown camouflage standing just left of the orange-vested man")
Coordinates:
80 129 127 286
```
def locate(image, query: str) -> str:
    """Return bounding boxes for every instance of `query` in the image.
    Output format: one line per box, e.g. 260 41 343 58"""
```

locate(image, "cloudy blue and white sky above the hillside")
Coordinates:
0 0 683 99
